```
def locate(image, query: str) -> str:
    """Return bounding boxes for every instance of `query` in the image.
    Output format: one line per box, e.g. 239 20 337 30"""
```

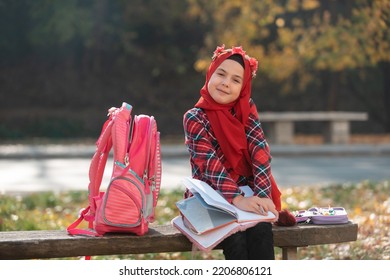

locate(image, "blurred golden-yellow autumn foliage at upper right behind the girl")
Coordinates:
190 0 390 131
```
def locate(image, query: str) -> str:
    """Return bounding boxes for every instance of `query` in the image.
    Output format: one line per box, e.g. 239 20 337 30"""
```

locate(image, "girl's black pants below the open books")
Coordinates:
221 222 275 260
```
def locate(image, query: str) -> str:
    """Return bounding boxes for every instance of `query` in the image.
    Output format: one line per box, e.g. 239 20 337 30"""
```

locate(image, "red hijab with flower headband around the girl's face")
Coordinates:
195 45 258 180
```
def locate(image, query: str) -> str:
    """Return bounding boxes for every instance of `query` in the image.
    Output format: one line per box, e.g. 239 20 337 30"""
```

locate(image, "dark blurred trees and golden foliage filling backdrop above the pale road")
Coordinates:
0 0 390 142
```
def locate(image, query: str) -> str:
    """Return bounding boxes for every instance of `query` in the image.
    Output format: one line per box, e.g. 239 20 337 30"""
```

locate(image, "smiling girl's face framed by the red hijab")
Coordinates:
207 59 244 104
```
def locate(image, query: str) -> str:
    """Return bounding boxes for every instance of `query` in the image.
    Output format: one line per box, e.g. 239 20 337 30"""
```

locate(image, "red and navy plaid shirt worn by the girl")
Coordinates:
183 100 271 202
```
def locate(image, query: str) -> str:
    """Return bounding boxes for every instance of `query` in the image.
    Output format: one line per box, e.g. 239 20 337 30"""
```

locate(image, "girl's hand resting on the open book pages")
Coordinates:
233 195 279 221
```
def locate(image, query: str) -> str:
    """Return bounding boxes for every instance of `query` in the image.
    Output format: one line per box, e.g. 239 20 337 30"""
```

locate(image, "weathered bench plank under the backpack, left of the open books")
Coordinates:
0 226 191 259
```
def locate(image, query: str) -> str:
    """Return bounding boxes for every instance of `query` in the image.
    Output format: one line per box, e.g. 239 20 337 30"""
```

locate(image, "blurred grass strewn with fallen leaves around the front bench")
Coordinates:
0 181 390 260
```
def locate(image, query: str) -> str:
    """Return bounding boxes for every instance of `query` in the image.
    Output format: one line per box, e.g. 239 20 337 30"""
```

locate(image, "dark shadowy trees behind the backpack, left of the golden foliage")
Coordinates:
0 0 209 137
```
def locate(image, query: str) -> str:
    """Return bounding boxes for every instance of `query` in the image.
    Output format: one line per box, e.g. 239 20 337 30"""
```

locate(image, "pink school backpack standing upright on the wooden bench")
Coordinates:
67 102 161 236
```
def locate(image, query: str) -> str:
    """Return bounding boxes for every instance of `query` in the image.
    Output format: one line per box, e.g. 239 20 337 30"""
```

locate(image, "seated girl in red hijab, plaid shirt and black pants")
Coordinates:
183 45 281 260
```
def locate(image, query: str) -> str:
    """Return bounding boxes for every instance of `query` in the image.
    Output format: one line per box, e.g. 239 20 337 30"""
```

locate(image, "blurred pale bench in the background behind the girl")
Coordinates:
259 112 368 144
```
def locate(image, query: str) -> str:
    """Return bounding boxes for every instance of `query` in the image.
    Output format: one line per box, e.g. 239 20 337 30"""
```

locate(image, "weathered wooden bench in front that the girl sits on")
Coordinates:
0 222 358 260
